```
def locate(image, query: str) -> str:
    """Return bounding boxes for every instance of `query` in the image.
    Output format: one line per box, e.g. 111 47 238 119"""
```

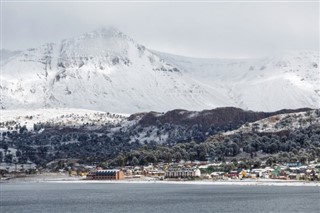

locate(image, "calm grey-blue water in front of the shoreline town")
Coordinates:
0 182 320 213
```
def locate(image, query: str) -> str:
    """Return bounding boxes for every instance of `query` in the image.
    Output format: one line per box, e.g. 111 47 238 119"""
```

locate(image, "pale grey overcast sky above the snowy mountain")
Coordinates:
1 2 319 58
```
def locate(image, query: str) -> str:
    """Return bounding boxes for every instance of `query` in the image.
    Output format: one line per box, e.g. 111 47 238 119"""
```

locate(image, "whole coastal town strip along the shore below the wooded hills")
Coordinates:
0 160 320 182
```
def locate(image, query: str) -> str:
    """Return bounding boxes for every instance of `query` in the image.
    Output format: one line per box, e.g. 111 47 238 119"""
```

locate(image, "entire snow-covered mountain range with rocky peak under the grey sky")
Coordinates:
1 28 320 113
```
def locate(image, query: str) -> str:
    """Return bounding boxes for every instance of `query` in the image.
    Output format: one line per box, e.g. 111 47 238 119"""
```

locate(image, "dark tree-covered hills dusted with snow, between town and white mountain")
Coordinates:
0 108 320 167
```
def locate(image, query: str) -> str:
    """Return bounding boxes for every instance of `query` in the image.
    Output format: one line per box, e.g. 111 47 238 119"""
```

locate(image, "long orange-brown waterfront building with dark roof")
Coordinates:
87 169 124 180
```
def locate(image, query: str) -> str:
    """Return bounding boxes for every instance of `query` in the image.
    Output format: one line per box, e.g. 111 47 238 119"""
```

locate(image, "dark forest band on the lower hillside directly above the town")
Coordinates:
0 116 320 166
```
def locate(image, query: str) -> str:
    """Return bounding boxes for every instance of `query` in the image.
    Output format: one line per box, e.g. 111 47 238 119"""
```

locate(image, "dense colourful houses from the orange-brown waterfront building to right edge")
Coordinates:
80 162 320 181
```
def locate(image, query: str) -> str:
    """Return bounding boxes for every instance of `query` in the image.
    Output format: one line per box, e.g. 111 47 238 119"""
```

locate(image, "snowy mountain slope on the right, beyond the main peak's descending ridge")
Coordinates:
158 51 320 111
